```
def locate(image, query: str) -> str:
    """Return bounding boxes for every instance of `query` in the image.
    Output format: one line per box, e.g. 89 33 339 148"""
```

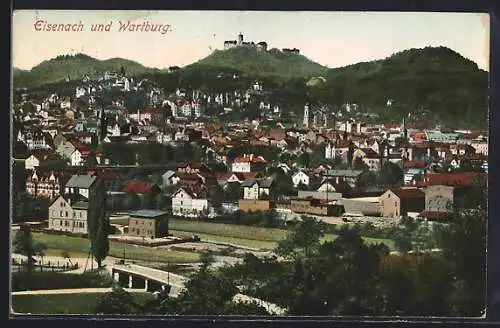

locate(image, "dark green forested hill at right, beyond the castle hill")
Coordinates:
316 47 488 128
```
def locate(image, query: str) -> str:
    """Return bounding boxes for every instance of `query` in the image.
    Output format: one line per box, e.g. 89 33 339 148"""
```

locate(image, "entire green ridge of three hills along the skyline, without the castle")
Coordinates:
13 47 488 128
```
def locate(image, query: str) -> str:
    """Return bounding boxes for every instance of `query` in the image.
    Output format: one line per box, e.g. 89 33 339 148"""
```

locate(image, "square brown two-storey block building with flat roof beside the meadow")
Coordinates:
128 210 168 239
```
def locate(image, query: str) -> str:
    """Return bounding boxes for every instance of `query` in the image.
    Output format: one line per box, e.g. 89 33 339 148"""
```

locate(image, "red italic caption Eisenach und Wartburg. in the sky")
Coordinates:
34 20 172 34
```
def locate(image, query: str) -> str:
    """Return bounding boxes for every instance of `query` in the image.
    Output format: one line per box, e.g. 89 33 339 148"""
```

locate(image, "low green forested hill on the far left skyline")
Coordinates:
13 54 159 87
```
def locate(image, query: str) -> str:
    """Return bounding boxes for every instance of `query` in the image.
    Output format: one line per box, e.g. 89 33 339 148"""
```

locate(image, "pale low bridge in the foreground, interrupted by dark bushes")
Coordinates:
111 264 287 315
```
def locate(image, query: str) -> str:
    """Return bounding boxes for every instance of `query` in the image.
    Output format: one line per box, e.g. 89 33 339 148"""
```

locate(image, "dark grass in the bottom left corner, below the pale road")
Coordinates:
12 293 154 314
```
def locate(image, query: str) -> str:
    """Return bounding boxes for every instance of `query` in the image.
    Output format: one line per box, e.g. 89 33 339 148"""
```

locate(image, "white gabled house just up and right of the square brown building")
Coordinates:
172 188 209 218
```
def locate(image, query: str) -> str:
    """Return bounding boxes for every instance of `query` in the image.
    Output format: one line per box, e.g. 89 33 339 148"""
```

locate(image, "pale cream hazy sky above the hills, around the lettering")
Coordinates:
12 10 490 70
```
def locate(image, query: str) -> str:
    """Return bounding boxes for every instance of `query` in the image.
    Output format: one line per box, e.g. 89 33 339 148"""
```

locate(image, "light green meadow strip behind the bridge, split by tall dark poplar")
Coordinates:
29 232 199 263
